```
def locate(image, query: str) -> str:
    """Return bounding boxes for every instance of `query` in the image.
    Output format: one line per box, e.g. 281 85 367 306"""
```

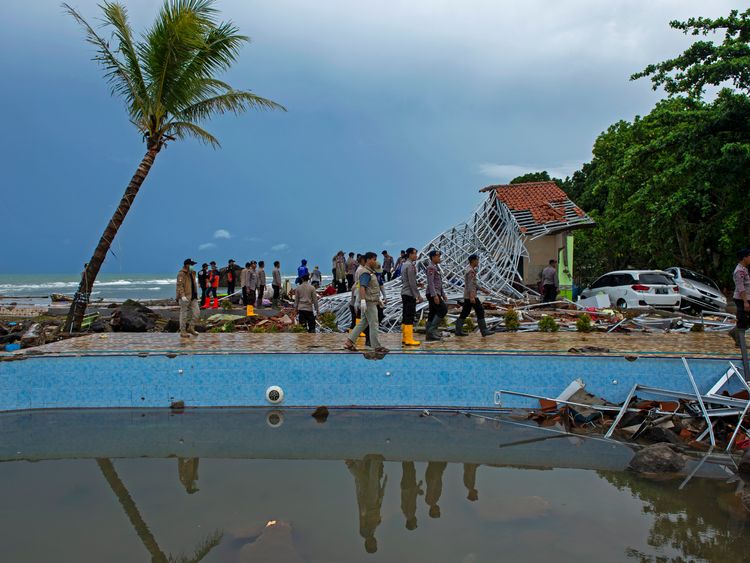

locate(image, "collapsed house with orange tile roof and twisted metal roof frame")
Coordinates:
321 182 594 332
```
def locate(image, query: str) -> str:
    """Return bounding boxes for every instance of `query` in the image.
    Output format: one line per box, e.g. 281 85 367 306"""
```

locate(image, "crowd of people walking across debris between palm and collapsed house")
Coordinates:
177 247 502 346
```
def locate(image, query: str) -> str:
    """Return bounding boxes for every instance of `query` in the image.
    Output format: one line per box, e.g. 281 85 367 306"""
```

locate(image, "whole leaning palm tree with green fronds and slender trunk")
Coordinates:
63 0 284 332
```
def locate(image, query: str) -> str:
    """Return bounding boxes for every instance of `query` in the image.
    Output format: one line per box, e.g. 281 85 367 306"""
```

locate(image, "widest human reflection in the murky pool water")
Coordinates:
346 454 388 553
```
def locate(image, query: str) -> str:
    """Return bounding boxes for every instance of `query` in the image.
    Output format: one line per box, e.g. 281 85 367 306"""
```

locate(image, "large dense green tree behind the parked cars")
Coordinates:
565 90 750 283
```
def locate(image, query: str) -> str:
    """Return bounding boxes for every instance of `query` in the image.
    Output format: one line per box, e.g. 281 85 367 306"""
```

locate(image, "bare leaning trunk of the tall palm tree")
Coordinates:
63 145 161 332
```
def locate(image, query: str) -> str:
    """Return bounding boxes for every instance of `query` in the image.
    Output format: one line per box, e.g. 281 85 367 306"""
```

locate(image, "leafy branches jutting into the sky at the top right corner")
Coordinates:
630 9 750 98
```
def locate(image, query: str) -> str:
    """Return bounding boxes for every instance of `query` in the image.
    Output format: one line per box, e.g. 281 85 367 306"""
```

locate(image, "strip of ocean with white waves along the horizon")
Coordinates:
0 269 324 304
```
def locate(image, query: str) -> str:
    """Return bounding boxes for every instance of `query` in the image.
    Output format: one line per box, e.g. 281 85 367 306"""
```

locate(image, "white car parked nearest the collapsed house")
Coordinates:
581 270 681 311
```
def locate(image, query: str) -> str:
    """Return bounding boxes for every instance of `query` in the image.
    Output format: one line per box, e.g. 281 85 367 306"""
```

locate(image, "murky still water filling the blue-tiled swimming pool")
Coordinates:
0 410 750 563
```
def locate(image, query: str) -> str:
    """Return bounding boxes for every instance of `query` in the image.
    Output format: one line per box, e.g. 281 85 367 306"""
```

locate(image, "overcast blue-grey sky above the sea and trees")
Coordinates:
0 0 740 273
